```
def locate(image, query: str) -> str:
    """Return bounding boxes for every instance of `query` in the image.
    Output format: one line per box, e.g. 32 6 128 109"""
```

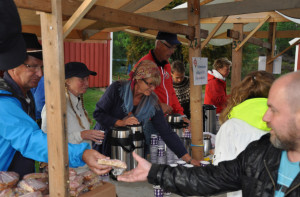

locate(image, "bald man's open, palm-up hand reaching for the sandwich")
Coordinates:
118 152 151 182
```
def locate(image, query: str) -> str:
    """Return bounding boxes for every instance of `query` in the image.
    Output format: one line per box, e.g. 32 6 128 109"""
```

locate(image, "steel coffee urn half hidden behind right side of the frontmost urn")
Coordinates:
127 124 145 169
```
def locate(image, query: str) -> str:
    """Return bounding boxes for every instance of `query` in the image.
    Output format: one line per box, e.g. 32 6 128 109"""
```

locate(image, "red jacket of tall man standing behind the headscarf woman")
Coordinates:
131 50 183 115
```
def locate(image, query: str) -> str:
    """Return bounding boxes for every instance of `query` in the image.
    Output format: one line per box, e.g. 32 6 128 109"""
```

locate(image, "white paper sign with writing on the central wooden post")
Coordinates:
192 57 207 85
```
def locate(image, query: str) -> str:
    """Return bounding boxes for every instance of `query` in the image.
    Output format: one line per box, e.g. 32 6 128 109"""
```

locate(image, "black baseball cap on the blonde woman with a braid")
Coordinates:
65 62 97 79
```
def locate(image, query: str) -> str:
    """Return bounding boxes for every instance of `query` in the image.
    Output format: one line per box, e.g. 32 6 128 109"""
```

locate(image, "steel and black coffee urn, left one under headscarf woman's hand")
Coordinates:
111 127 135 170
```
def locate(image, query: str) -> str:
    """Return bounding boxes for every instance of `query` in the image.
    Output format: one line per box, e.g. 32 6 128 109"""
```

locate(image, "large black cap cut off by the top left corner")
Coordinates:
0 0 27 70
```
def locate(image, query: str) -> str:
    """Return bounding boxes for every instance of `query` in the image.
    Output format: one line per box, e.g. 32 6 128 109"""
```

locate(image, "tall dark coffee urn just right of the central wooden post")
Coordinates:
203 104 218 134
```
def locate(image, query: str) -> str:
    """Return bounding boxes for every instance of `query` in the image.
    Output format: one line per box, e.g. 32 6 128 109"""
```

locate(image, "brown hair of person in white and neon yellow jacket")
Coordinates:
219 71 275 124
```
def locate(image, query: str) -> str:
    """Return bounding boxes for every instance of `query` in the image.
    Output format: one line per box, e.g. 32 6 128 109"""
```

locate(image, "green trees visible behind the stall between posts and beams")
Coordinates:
113 0 300 80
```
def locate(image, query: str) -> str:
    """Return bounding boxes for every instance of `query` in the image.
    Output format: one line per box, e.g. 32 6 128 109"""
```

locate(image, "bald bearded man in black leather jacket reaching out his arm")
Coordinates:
118 72 300 197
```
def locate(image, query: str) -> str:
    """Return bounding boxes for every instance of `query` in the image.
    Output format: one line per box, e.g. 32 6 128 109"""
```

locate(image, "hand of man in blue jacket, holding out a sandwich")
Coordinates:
82 149 111 175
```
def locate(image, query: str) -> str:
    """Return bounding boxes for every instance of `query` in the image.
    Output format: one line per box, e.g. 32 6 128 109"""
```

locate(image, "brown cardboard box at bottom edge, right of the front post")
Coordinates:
80 182 117 197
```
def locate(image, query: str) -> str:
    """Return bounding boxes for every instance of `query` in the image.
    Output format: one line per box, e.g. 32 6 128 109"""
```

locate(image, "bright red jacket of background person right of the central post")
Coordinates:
204 73 227 114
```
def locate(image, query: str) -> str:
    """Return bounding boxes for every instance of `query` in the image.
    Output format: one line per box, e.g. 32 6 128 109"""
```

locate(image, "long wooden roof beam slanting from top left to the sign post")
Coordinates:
15 0 200 39
